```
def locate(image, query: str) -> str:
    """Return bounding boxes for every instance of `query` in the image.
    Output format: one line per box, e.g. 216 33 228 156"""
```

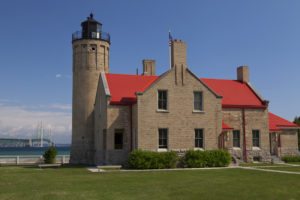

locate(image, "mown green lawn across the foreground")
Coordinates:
0 167 300 200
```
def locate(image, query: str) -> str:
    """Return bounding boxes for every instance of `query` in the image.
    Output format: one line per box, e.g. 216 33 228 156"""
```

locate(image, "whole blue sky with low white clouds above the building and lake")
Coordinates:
0 0 300 143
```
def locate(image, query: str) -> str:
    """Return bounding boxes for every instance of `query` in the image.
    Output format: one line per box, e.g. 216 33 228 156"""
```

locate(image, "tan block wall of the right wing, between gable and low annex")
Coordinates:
223 108 271 161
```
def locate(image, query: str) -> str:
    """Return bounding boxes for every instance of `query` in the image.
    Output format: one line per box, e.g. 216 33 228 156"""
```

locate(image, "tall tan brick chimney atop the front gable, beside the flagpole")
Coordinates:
171 39 187 67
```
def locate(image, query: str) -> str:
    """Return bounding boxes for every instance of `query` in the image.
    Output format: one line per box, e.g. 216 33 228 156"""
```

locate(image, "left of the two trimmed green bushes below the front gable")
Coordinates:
128 150 178 169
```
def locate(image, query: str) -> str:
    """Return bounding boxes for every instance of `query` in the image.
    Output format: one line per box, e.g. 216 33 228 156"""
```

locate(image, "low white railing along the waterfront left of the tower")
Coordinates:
0 155 70 165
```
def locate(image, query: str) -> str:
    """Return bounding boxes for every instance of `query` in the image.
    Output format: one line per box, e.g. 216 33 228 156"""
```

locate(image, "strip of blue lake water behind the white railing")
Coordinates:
0 146 70 156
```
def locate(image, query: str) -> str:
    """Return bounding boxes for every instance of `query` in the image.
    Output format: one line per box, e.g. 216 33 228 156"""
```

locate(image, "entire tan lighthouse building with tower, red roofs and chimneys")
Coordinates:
71 15 299 164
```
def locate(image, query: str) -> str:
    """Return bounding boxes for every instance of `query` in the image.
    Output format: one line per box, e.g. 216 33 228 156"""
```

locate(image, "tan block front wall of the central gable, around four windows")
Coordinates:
137 67 222 151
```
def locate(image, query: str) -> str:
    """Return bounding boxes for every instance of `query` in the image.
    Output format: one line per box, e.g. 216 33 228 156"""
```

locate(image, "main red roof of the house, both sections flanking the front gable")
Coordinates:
106 74 266 108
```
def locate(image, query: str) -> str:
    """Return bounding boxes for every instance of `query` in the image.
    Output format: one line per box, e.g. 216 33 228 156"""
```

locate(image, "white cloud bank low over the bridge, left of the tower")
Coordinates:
0 104 72 143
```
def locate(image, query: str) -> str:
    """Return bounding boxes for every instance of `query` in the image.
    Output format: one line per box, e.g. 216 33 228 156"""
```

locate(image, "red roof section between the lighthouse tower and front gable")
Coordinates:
106 74 158 105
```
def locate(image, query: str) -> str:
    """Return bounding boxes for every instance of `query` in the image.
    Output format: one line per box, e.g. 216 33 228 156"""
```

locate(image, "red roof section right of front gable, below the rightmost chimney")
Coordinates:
201 78 266 108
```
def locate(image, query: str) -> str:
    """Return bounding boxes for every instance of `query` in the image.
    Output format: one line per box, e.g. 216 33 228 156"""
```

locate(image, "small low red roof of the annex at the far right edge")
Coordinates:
269 112 300 131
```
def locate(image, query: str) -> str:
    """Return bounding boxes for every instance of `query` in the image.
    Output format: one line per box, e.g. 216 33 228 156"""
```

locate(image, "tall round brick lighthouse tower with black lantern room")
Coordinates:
70 14 110 164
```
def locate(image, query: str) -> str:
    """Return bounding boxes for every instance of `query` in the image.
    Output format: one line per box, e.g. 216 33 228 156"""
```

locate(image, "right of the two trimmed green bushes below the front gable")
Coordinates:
183 150 231 168
